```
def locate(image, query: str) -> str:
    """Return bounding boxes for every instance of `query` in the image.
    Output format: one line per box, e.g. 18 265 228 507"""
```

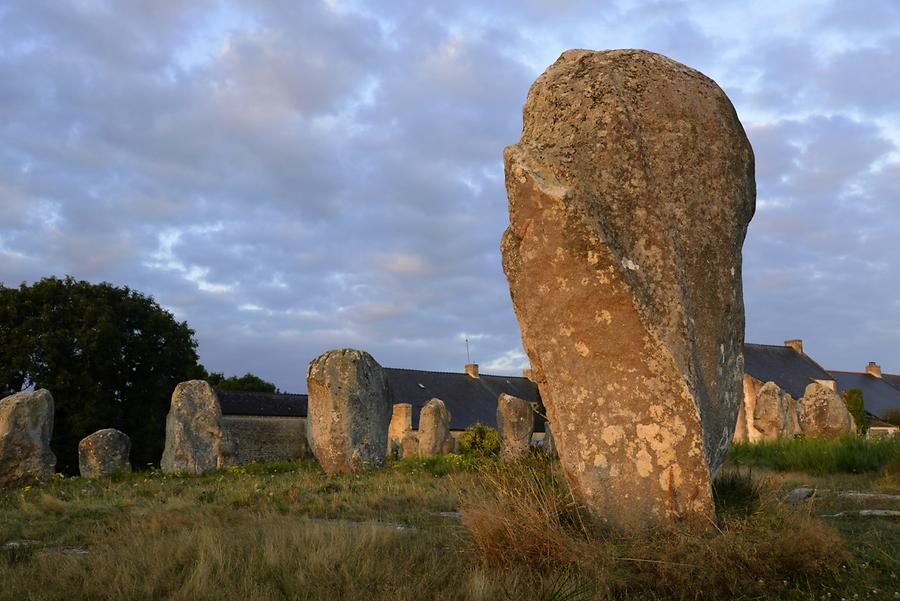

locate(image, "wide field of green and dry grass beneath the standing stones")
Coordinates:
0 440 900 601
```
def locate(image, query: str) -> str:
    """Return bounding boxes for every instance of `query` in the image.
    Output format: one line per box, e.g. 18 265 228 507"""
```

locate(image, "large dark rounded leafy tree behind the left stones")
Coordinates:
0 277 206 473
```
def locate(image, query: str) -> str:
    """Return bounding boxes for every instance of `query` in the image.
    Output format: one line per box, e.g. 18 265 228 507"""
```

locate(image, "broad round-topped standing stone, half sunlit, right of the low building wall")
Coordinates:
306 349 393 473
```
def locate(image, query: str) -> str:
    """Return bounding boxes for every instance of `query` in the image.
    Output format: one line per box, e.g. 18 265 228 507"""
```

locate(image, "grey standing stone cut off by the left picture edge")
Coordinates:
0 388 56 487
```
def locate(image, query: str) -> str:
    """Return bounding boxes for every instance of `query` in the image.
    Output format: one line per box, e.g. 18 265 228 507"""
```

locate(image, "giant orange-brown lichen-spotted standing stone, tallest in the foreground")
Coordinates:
501 50 755 528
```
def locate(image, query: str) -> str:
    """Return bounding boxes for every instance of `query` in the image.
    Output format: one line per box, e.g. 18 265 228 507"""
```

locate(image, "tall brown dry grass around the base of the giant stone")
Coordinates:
461 459 847 599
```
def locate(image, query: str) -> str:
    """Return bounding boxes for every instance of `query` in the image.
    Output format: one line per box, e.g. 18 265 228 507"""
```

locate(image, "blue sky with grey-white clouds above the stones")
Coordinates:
0 0 900 392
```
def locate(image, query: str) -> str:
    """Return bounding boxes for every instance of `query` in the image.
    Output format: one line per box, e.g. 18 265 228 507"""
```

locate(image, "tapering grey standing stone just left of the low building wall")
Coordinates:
160 380 236 474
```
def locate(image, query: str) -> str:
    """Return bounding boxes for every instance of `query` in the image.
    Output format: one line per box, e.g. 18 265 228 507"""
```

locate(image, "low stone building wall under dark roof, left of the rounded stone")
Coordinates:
222 415 309 463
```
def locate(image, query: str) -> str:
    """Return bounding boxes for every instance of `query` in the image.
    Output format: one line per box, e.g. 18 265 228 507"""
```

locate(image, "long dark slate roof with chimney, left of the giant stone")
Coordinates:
385 367 544 432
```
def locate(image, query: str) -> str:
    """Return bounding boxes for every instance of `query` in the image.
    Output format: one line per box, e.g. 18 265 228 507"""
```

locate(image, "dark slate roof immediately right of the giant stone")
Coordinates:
744 342 834 399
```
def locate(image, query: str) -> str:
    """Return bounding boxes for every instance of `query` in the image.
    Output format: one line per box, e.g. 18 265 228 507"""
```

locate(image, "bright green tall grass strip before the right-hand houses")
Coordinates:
728 435 900 475
